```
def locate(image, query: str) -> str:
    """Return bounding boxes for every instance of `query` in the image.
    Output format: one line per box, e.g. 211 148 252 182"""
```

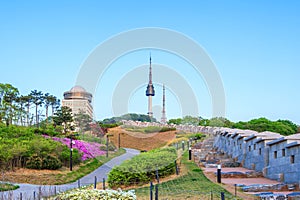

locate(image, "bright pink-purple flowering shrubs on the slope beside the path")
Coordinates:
44 135 105 160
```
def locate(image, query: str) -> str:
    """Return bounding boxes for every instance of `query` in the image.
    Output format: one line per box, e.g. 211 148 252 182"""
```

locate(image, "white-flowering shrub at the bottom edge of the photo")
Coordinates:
50 188 136 200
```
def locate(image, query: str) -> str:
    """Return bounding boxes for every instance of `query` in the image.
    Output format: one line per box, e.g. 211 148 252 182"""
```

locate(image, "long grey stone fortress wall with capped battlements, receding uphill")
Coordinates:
123 121 300 184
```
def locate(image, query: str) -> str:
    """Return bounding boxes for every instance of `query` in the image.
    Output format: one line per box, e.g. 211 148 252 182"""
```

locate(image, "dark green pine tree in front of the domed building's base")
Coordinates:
53 106 74 134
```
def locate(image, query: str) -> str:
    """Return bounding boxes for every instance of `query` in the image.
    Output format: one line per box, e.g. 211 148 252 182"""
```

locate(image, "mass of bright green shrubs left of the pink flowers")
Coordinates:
0 125 81 170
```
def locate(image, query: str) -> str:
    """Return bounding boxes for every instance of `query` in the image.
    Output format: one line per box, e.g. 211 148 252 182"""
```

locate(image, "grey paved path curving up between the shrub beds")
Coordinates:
0 148 139 200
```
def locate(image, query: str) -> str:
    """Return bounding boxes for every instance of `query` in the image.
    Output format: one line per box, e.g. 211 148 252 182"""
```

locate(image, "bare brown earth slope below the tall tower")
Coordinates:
108 127 176 151
